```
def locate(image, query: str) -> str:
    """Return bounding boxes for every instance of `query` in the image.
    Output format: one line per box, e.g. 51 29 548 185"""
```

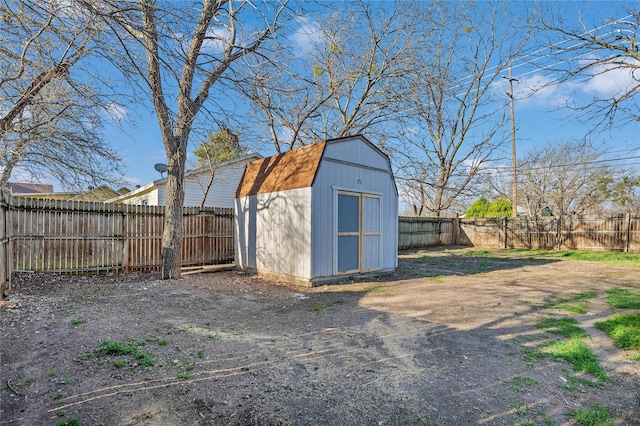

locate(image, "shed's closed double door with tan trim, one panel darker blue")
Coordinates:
337 191 381 274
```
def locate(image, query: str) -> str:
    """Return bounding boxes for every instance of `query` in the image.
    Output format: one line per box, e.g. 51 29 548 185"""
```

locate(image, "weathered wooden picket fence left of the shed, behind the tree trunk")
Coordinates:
0 196 233 296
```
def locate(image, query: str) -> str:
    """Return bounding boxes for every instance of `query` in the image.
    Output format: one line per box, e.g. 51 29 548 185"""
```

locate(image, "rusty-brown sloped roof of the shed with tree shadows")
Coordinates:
236 142 326 197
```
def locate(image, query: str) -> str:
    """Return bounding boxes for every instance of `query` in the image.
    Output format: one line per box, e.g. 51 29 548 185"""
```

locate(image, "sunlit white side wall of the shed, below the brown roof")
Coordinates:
235 188 312 282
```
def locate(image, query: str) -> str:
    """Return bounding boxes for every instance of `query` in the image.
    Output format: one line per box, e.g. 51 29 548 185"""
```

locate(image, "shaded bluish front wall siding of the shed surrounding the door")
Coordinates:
311 141 398 279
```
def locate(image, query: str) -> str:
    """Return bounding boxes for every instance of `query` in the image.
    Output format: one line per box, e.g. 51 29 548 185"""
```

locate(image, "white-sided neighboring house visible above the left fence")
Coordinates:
106 153 262 208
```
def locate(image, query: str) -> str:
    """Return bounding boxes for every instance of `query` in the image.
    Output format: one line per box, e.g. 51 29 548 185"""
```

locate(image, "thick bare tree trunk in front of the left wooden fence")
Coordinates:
162 138 187 280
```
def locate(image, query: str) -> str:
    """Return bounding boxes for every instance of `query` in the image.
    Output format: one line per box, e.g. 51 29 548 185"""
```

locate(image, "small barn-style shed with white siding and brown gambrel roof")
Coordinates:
234 136 398 287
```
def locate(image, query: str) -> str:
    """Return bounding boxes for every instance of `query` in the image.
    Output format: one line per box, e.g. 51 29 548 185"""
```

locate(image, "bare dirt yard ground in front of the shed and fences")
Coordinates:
0 250 640 425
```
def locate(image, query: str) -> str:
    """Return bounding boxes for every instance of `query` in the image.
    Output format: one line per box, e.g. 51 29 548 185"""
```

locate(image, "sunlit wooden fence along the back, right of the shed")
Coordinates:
398 213 640 252
